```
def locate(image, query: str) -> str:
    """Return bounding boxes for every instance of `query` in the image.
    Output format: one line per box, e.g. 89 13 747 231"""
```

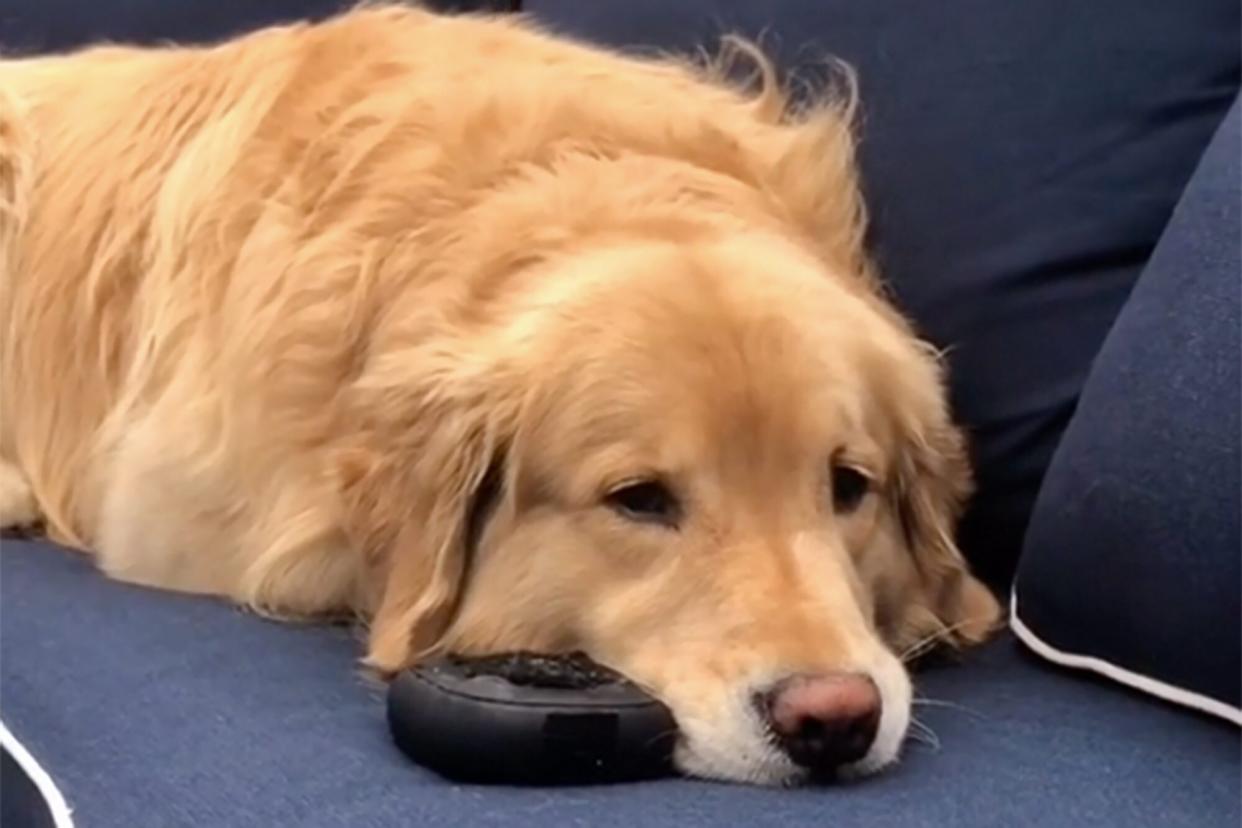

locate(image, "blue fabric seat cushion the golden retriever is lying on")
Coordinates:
0 542 1242 828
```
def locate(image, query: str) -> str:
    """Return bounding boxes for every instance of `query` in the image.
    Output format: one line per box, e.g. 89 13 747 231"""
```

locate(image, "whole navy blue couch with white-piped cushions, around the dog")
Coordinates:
0 0 1242 828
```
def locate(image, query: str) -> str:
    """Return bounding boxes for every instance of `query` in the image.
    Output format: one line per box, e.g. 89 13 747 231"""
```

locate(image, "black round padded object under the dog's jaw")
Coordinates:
388 653 677 785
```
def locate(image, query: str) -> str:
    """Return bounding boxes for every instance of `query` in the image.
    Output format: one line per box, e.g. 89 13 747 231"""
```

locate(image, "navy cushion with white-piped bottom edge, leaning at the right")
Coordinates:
1016 103 1242 708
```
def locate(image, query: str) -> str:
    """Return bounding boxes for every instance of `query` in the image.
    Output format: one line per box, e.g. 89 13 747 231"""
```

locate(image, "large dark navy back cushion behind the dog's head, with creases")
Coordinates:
524 0 1242 585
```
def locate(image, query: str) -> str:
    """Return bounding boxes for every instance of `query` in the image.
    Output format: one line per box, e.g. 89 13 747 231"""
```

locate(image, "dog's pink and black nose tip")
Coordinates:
755 673 881 771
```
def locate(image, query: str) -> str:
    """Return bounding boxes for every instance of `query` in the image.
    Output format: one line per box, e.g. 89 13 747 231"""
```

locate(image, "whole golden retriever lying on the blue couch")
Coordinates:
0 6 999 785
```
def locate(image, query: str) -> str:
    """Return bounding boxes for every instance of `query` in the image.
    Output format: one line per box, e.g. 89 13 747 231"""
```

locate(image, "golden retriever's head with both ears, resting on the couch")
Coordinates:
339 235 997 783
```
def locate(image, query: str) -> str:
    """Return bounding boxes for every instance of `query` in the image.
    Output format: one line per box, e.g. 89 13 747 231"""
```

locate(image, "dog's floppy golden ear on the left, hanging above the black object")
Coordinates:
335 347 512 674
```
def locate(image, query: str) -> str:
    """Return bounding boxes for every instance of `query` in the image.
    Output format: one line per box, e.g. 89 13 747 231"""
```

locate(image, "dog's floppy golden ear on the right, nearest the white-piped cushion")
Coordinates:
895 350 1001 649
